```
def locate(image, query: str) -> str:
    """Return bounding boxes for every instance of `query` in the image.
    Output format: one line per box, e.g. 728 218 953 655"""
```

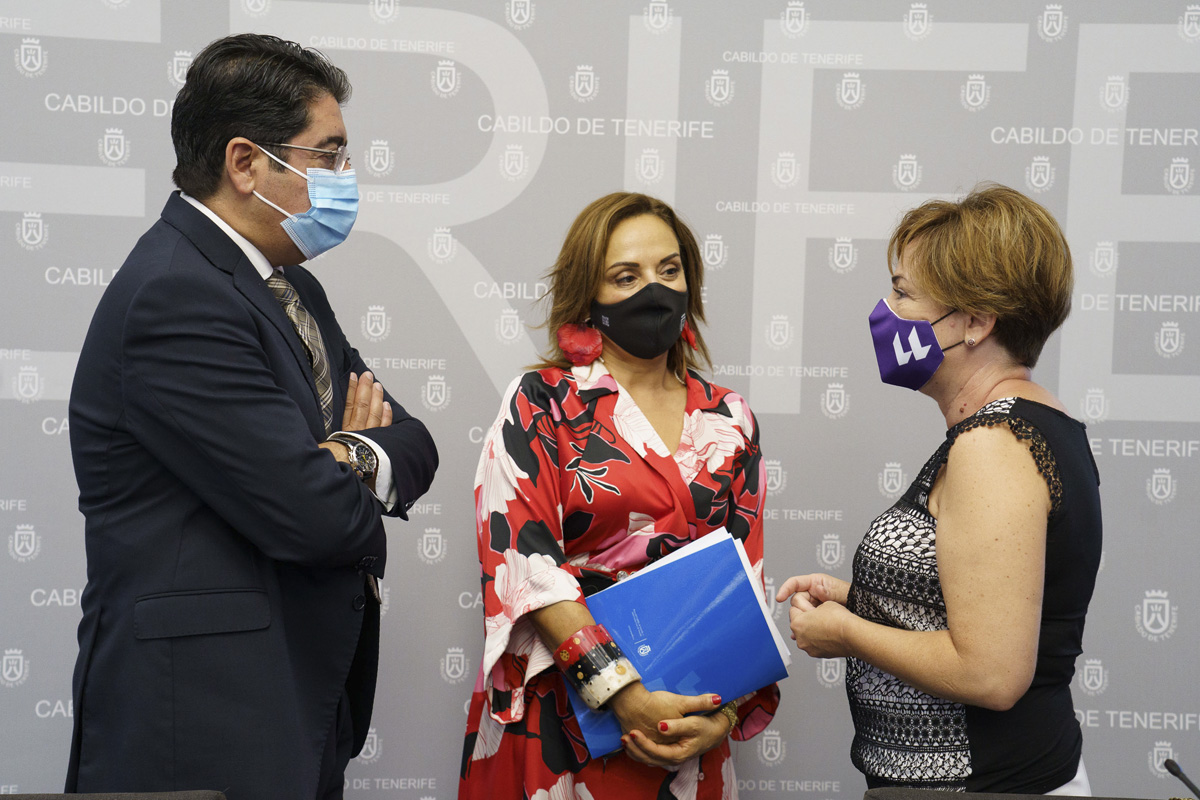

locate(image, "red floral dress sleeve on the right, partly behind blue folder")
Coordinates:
725 393 779 741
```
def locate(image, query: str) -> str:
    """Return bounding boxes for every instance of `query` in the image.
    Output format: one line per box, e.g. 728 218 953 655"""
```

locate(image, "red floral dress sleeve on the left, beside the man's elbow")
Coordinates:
475 372 583 723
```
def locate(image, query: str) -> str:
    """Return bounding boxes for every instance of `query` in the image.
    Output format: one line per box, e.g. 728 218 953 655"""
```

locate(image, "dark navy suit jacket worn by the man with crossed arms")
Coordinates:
66 194 437 800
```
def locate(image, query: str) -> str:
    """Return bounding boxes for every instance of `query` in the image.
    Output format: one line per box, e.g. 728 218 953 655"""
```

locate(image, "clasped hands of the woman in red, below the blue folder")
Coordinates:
608 682 730 769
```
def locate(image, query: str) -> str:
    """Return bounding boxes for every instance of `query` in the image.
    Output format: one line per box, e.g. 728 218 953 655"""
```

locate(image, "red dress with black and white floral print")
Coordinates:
458 362 779 800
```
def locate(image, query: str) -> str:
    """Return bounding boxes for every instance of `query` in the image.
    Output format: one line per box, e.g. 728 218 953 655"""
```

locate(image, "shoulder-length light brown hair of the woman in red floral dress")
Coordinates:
535 192 712 375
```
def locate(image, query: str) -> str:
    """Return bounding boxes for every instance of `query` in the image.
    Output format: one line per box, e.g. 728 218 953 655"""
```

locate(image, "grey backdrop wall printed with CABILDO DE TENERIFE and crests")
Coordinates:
0 0 1200 800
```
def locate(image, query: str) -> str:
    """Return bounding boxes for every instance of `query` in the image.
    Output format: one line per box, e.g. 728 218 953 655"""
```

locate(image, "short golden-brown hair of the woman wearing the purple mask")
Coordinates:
888 184 1075 367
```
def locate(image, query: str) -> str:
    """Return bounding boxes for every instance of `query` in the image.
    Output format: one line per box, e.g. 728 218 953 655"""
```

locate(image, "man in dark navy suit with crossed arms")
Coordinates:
67 35 438 800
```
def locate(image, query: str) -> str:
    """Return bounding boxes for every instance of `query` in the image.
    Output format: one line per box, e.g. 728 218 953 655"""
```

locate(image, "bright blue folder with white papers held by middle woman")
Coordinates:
568 529 791 757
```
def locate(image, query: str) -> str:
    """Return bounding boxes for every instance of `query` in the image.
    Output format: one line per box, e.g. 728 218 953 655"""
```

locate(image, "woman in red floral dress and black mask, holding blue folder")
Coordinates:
458 193 779 800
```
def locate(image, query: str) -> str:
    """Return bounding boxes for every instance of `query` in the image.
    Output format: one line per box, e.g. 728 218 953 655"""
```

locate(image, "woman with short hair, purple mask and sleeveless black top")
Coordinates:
779 185 1102 794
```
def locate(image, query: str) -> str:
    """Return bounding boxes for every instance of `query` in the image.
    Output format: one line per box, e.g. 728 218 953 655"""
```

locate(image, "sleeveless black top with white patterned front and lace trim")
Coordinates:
846 398 1100 794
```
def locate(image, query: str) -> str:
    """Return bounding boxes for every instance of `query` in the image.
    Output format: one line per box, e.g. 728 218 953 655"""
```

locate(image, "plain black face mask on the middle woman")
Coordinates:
592 283 688 359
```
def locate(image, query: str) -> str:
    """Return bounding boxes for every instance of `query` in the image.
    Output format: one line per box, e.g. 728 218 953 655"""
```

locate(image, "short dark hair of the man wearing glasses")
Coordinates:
170 34 350 200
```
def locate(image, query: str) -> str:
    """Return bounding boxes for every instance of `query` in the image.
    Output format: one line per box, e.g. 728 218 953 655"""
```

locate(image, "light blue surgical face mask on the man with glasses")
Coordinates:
254 142 359 259
